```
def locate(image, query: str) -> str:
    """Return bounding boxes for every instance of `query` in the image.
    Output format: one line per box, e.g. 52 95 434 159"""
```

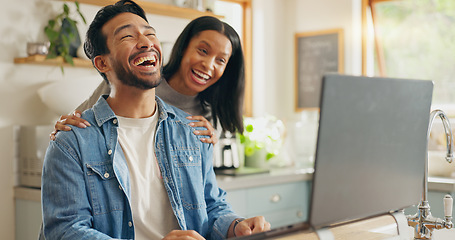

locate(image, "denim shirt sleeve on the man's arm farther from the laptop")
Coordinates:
41 136 111 240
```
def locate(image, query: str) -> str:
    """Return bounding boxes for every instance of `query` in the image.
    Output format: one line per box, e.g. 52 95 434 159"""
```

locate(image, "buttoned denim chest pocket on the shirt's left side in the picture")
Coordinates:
86 161 124 215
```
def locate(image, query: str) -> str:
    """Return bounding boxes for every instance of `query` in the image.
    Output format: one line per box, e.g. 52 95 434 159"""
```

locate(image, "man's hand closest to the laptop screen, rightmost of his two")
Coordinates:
228 216 270 237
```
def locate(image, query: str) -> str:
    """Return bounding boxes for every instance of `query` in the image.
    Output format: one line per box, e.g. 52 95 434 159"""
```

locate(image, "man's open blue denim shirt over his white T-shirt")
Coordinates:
41 96 239 240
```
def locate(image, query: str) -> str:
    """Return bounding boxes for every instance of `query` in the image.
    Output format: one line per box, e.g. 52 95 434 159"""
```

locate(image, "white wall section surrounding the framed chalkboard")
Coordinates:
253 0 361 120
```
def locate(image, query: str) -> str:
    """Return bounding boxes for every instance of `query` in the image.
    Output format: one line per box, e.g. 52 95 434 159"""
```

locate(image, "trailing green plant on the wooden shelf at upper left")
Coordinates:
44 1 87 68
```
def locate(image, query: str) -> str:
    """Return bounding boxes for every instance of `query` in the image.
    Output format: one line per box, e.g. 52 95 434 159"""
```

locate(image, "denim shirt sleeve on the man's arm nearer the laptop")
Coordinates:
202 144 241 240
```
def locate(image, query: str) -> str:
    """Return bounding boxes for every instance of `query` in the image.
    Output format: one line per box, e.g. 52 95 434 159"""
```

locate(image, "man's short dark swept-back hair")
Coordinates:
84 0 148 83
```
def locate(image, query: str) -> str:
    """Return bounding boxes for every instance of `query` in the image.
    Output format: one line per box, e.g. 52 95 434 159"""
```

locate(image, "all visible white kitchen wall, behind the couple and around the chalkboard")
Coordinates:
0 0 360 239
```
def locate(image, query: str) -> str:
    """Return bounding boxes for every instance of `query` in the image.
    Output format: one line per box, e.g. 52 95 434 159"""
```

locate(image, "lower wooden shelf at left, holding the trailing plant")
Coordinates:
14 55 93 68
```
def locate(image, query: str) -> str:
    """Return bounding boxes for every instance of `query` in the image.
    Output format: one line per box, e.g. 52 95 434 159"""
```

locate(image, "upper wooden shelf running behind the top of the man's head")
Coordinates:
71 0 224 19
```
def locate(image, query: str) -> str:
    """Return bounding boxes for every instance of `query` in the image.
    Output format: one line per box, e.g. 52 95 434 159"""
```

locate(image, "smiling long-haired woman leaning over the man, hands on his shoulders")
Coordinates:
51 16 245 143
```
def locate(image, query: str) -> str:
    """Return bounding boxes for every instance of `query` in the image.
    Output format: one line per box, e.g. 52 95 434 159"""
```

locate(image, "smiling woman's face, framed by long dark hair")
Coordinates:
168 30 232 96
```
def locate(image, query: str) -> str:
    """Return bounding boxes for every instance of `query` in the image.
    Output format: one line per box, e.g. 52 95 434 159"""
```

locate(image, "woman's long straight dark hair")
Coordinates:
163 16 245 133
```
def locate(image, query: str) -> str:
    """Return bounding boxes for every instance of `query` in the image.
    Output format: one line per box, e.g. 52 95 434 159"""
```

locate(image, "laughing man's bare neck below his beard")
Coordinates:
106 87 156 118
